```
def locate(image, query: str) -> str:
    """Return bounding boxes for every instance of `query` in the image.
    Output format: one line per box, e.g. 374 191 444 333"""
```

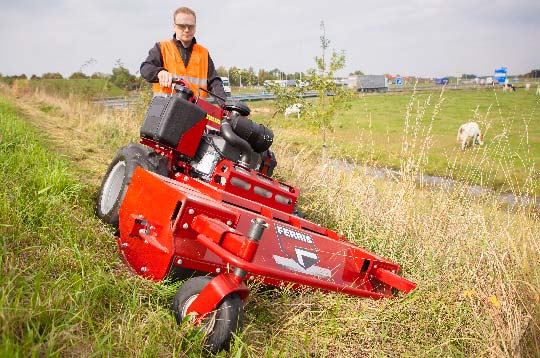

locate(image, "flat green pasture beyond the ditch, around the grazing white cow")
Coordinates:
250 89 540 195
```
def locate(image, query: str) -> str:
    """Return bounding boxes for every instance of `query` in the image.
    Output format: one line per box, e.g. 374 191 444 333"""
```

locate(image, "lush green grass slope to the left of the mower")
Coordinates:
0 95 211 357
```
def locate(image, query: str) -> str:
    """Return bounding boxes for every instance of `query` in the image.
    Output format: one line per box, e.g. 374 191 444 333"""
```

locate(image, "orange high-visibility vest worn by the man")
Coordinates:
152 40 208 98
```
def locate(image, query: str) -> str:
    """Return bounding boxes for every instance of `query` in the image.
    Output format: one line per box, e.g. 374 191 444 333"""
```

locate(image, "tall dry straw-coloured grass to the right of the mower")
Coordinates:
266 86 540 356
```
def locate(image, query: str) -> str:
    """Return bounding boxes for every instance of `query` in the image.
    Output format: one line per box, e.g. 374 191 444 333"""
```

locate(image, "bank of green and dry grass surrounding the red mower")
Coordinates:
0 82 540 357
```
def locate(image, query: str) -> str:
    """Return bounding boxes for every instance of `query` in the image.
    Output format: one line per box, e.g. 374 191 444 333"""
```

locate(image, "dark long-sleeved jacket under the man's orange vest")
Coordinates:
140 35 226 98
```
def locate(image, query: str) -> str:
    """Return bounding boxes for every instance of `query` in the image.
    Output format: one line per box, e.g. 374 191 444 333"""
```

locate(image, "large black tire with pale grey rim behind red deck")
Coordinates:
95 143 167 230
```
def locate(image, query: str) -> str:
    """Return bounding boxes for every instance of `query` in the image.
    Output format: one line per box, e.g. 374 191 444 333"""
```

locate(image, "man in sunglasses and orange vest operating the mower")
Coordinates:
141 7 225 98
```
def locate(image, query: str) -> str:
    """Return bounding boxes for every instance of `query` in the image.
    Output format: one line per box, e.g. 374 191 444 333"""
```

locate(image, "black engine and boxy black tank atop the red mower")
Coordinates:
141 92 277 180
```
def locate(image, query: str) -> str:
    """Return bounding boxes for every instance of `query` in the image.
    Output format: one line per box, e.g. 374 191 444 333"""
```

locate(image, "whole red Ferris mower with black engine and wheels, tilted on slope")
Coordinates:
96 78 416 352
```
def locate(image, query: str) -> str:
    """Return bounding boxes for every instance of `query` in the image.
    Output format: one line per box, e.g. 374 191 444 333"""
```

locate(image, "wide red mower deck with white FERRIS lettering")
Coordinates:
118 168 416 299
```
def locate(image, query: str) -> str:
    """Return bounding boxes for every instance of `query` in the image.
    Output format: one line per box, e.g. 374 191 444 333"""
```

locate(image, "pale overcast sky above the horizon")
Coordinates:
0 0 540 77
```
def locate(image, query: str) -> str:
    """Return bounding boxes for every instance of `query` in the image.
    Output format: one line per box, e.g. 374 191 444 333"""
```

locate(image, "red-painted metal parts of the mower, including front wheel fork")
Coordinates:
118 87 416 322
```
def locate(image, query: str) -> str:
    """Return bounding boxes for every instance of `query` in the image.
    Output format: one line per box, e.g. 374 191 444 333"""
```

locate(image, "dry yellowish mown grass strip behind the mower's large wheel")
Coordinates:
4 86 151 184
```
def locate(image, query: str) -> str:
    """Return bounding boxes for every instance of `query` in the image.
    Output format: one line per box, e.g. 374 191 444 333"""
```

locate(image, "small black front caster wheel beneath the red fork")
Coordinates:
171 276 244 354
